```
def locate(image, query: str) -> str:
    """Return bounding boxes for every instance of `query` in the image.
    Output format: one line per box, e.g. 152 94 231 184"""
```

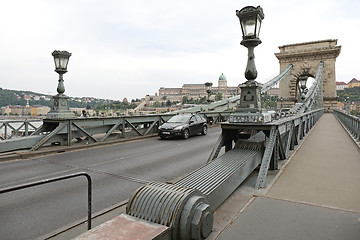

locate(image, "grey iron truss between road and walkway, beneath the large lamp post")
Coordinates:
222 109 324 189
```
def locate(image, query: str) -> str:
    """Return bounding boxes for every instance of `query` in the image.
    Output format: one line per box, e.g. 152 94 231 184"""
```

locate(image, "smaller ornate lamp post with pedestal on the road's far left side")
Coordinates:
47 50 75 119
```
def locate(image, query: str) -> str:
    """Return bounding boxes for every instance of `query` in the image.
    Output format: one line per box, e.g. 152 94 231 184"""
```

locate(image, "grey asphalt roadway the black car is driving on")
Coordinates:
0 128 221 240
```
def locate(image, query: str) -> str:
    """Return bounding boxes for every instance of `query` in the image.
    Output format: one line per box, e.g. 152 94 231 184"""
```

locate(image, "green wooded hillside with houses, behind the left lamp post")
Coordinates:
0 88 136 110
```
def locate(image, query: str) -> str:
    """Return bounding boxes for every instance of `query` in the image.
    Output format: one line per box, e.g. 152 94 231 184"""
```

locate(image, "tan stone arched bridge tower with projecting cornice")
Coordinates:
275 39 341 109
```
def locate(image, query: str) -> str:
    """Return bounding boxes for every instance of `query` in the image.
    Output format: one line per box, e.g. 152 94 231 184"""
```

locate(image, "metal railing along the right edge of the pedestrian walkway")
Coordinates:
334 110 360 147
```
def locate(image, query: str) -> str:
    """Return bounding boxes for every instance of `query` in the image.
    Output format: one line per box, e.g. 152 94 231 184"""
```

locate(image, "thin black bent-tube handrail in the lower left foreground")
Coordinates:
0 172 92 230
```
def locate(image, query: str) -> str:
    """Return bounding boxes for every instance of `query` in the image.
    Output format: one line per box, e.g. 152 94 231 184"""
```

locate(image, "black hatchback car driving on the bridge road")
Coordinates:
158 113 208 139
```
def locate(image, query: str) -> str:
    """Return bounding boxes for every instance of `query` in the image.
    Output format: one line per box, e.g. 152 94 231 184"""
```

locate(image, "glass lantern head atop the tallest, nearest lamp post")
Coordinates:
236 6 264 39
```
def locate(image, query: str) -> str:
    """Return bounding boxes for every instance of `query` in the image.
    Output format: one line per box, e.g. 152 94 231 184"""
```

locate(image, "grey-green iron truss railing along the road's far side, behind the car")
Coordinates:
0 112 231 153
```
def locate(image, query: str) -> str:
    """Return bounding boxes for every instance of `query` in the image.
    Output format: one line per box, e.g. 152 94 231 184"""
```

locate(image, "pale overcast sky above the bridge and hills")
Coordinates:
0 0 360 100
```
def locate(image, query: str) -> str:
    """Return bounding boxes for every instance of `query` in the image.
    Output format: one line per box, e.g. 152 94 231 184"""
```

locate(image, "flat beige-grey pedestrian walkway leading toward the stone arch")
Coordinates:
208 114 360 240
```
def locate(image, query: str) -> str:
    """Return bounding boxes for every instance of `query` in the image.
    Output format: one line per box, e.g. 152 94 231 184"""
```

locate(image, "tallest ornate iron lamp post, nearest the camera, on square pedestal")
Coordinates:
236 6 264 113
